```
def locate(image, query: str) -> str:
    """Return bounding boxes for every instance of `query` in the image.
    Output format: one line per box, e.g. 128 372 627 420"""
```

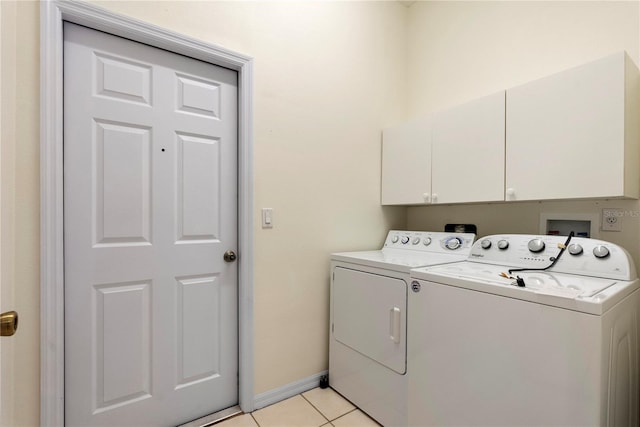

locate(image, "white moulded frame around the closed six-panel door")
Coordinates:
40 0 255 426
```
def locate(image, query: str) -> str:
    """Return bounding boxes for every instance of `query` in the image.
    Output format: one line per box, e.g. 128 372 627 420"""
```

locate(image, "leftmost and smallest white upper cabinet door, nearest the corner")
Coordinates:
381 116 431 205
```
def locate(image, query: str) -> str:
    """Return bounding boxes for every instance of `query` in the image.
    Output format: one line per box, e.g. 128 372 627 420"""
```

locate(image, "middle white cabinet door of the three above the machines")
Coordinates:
431 91 505 203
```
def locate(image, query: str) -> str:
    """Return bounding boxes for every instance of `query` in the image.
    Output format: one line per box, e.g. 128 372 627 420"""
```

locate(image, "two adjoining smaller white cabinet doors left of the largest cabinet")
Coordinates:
382 91 505 205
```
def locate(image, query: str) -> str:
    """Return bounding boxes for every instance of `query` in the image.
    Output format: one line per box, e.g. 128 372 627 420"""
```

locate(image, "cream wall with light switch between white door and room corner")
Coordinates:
93 2 406 393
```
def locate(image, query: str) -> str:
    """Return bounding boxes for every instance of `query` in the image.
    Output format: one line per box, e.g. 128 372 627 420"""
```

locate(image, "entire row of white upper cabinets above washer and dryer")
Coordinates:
382 52 640 205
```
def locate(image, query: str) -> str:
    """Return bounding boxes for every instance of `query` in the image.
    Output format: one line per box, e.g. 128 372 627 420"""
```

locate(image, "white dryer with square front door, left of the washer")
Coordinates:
329 230 475 426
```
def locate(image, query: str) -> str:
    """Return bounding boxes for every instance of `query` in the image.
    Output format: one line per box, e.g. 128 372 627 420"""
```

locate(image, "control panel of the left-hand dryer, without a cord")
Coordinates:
383 230 476 253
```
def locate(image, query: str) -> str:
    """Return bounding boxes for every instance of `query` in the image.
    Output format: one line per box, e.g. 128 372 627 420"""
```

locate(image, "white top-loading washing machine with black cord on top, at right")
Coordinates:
407 235 640 427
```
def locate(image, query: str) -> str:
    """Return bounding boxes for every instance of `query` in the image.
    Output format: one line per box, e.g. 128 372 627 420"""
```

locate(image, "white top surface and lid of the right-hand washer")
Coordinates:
411 261 640 314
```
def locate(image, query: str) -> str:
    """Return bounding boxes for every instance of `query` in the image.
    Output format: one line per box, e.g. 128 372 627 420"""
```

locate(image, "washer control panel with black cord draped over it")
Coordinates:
468 234 636 280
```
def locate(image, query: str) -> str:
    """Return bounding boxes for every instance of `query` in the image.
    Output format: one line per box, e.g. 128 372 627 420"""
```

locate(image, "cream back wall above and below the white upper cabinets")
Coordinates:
407 1 640 267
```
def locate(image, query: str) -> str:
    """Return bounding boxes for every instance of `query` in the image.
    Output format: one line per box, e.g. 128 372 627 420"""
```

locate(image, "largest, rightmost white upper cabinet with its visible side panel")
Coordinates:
506 52 640 200
